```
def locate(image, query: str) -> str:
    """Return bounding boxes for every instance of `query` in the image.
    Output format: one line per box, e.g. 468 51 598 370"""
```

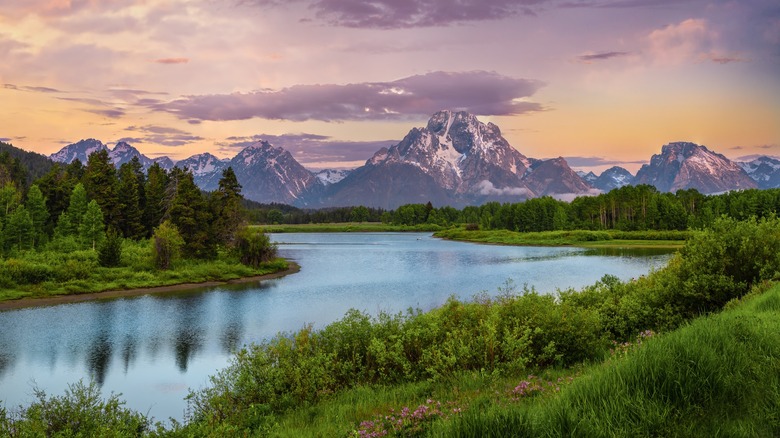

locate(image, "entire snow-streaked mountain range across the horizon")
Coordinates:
50 111 780 209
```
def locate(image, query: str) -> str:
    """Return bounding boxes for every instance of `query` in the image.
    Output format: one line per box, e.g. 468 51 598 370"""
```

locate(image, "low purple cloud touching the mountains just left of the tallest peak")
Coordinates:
217 133 398 167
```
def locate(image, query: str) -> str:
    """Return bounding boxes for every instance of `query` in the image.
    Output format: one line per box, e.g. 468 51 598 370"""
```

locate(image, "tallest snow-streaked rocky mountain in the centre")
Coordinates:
321 111 590 208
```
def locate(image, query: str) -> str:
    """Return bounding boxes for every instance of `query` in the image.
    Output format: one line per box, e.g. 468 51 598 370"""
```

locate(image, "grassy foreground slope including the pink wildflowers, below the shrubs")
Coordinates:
206 284 780 437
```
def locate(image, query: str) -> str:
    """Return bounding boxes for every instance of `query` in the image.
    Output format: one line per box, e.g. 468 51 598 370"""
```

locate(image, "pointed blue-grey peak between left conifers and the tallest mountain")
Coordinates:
228 141 325 206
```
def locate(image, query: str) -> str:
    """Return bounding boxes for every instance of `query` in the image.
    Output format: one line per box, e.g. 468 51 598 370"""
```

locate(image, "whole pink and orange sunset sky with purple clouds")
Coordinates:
0 0 780 172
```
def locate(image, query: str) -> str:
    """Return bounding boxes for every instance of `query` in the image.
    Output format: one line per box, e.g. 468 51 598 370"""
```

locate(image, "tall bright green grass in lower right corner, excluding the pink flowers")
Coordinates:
430 285 780 437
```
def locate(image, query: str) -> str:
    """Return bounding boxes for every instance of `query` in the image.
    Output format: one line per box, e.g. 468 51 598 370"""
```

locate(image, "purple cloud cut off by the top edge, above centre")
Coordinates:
238 0 550 29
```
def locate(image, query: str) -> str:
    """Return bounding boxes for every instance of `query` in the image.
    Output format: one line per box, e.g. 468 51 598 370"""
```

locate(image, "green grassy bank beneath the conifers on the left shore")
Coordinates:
0 240 288 301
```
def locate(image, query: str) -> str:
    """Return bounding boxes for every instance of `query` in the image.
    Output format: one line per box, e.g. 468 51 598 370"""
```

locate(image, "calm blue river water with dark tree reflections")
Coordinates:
0 233 669 419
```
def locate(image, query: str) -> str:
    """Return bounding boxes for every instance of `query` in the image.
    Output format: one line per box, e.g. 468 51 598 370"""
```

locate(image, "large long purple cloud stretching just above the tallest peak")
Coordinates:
151 71 543 121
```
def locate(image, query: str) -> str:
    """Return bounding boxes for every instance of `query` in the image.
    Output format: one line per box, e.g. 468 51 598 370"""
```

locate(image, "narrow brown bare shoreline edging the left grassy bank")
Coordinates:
0 261 301 311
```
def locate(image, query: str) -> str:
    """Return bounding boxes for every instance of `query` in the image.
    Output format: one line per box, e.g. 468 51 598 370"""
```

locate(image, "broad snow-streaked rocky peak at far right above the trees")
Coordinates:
633 142 757 194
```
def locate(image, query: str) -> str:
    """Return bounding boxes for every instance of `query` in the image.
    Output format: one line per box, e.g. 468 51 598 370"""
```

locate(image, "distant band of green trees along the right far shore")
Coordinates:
382 185 780 232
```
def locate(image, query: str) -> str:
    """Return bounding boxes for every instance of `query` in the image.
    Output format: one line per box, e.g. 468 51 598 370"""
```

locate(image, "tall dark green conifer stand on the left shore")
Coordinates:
0 147 268 268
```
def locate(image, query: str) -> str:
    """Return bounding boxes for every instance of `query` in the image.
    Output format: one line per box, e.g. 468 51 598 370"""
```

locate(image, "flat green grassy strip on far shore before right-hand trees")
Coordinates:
434 228 690 248
